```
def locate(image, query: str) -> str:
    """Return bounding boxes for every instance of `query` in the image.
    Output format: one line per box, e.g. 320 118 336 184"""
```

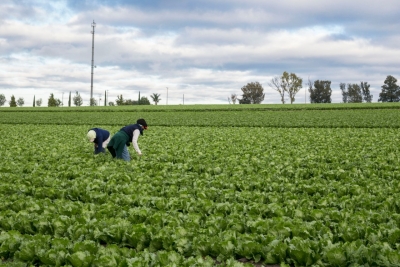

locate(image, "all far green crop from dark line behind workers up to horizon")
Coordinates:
0 103 400 128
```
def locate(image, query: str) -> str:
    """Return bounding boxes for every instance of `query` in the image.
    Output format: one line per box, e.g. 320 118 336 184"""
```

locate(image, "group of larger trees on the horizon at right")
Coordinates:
228 71 400 104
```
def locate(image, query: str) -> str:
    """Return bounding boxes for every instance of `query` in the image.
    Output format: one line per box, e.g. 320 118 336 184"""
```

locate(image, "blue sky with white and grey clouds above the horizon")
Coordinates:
0 0 400 106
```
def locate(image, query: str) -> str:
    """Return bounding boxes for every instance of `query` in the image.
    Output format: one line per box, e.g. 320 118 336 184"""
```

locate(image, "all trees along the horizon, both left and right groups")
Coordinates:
0 75 400 107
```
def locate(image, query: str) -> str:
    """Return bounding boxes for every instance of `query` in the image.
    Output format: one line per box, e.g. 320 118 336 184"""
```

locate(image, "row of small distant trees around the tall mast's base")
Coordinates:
0 91 161 107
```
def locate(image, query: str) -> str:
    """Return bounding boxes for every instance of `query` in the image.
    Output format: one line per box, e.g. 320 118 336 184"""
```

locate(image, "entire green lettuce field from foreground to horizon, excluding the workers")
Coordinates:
0 104 400 267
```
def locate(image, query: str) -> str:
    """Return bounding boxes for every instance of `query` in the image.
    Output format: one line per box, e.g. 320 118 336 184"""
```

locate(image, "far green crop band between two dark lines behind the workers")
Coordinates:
0 109 400 128
